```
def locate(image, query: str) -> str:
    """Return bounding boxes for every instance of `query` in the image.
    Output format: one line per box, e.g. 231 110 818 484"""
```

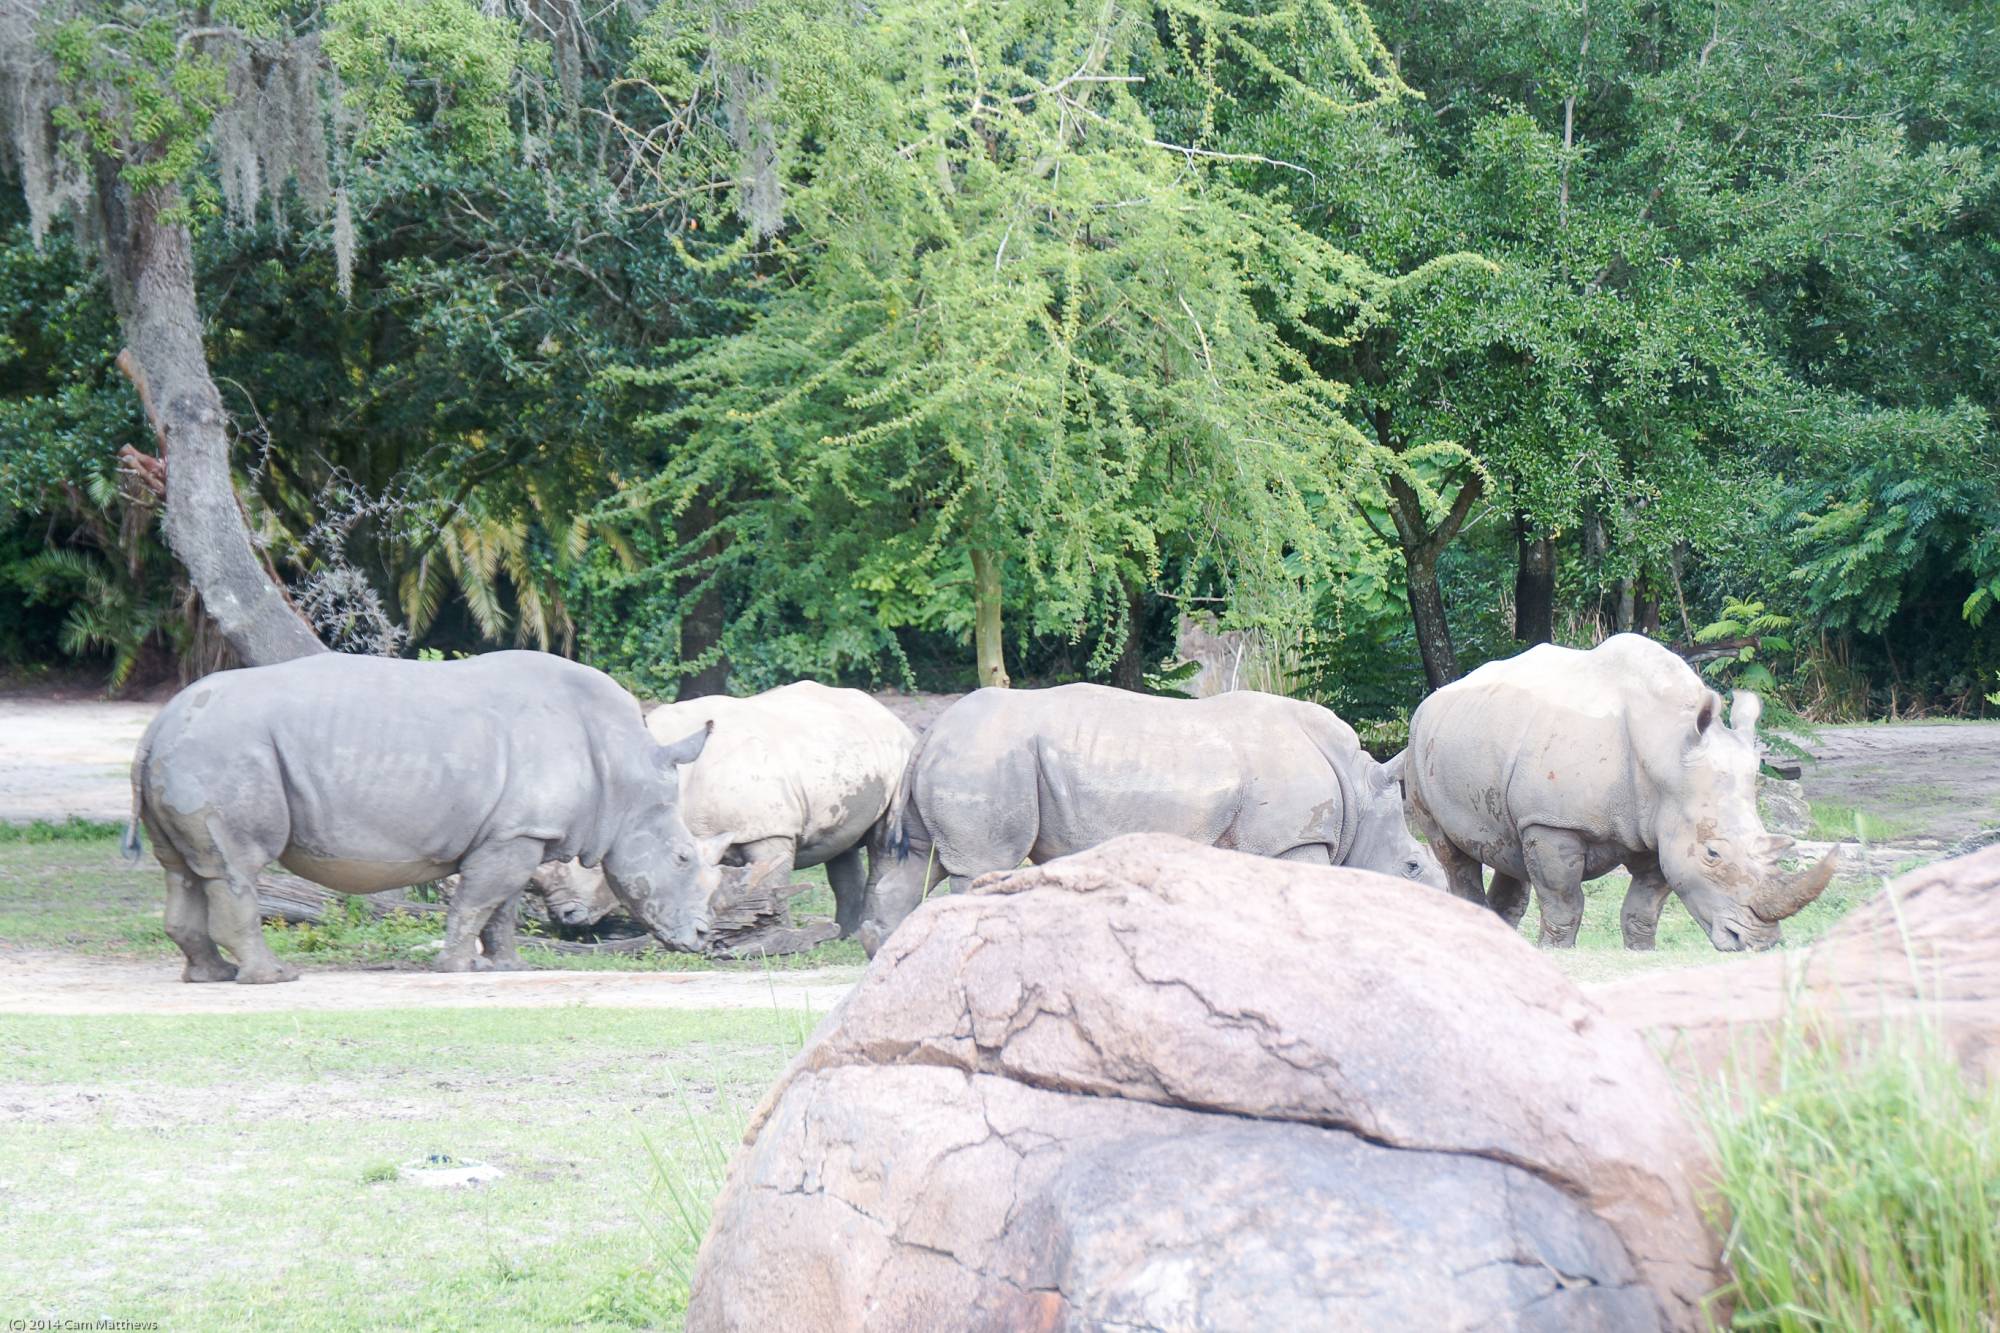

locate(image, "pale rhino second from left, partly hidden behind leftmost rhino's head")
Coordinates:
536 681 916 949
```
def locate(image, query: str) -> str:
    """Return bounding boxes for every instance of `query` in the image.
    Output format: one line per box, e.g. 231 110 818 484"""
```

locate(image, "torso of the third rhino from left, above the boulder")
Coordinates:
912 685 1352 861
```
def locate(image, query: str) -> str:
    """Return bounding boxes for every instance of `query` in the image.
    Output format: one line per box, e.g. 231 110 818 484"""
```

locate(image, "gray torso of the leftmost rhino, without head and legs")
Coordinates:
146 652 646 865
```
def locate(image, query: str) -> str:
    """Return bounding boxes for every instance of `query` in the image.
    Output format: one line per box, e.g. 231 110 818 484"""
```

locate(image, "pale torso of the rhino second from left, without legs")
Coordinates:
646 681 916 867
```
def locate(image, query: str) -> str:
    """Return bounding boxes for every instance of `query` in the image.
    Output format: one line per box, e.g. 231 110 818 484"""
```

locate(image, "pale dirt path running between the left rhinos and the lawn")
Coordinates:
0 949 860 1015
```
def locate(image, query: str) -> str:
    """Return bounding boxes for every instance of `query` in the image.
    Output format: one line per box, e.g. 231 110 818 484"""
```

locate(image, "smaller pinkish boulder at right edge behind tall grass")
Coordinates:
1592 847 2000 1085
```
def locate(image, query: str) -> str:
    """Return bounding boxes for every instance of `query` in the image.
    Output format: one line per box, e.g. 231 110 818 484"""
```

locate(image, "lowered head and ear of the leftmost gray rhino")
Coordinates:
604 723 730 953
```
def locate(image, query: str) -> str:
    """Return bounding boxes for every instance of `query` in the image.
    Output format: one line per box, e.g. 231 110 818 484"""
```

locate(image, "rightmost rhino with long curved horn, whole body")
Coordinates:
1404 634 1834 951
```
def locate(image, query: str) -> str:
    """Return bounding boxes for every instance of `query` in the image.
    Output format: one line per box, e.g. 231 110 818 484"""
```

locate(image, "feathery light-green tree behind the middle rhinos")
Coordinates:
608 0 1472 685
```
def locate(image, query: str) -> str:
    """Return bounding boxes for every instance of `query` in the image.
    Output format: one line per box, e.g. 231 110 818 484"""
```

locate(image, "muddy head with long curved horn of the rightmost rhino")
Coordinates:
1658 691 1838 951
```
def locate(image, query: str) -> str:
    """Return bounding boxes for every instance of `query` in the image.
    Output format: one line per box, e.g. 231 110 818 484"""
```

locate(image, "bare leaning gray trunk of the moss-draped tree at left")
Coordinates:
96 174 326 667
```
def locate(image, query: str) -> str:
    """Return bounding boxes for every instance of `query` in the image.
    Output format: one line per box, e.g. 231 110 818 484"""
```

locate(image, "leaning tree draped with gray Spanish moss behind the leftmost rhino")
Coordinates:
0 0 520 664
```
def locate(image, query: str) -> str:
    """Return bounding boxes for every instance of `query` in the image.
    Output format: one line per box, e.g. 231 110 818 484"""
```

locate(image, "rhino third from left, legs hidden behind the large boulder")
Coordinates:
862 685 1444 953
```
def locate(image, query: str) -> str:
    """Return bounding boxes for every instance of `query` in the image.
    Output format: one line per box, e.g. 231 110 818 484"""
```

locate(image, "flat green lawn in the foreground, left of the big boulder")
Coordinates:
0 1009 810 1329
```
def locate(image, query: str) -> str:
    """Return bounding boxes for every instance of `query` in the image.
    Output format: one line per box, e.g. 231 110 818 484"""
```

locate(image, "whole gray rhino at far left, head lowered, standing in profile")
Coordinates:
126 652 718 981
